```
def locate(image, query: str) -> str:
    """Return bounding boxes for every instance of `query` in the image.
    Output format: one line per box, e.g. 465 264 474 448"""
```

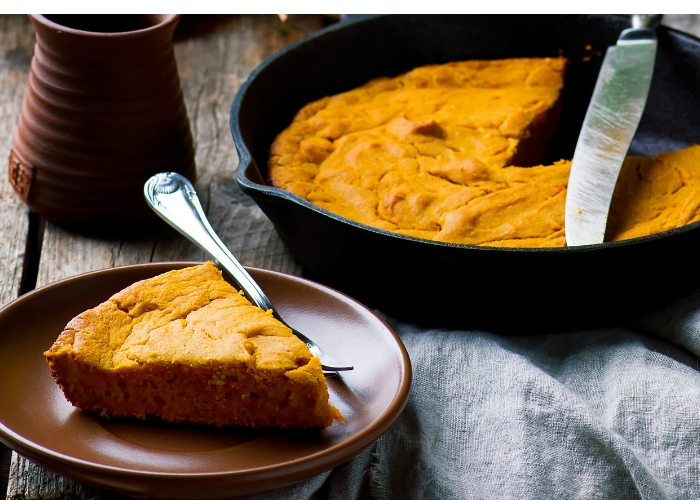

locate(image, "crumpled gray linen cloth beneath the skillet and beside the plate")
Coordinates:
245 290 700 499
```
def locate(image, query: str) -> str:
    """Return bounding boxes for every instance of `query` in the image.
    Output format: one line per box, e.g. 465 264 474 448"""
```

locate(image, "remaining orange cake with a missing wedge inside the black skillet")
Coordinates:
268 58 700 247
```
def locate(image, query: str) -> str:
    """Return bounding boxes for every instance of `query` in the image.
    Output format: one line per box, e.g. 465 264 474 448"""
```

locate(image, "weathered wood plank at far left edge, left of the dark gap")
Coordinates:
0 15 34 498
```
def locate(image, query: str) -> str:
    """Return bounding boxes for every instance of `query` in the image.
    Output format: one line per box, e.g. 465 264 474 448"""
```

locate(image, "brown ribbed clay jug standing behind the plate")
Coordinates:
9 14 195 226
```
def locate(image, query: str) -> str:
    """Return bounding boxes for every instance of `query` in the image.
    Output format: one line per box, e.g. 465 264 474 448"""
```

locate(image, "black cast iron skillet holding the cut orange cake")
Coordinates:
231 15 700 333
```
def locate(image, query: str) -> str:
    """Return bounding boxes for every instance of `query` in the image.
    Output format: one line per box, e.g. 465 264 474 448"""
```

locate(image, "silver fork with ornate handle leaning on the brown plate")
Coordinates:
143 172 353 372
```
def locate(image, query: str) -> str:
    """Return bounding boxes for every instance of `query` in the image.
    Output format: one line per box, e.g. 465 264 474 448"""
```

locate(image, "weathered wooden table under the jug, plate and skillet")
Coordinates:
0 15 700 500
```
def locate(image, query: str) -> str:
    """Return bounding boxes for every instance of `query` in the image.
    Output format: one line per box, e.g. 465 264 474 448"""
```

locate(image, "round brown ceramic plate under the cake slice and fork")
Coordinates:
0 263 411 498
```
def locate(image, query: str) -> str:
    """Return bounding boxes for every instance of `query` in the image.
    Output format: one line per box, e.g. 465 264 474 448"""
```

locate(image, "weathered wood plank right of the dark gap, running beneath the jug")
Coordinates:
7 15 322 500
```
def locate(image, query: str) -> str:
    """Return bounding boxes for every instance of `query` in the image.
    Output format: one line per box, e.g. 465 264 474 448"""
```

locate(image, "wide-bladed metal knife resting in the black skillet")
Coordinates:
564 14 662 247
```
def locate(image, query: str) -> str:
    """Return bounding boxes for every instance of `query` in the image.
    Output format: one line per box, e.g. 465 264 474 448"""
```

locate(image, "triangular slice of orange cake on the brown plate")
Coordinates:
44 262 343 428
